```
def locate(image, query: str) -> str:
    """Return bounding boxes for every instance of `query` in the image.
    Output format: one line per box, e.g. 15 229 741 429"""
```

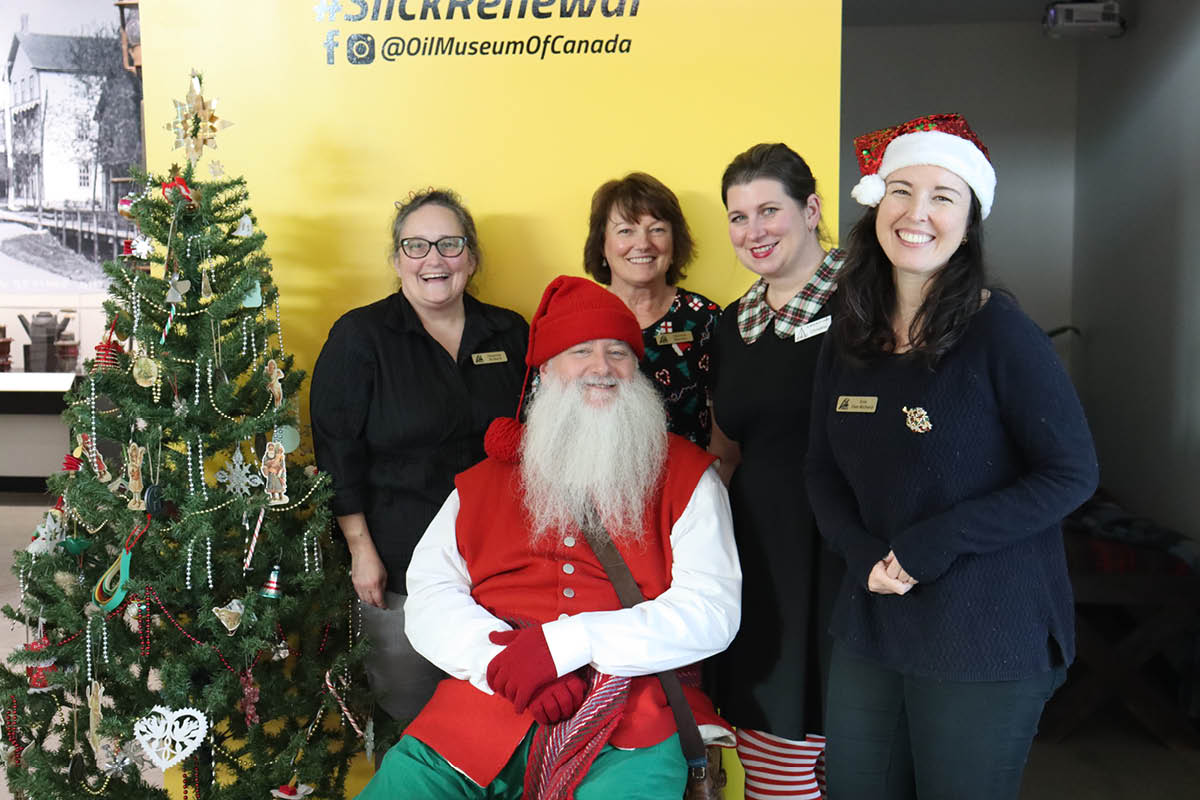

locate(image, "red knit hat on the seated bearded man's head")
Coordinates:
526 275 646 367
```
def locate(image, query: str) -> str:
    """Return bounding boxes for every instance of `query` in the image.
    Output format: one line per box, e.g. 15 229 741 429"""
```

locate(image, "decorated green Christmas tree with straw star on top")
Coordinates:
0 76 372 800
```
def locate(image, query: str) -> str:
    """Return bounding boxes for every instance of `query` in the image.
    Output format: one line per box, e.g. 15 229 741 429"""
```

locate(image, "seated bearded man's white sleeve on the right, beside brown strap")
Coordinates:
542 467 742 676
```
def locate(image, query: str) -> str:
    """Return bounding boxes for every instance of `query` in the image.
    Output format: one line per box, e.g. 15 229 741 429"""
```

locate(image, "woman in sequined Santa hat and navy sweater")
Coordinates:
806 114 1098 800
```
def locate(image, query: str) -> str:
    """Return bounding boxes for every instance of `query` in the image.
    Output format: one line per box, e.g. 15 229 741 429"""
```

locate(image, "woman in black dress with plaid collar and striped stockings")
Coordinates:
713 144 845 798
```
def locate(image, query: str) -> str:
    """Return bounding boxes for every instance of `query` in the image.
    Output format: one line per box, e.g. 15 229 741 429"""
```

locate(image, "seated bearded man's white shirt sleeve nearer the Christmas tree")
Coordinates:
404 489 511 694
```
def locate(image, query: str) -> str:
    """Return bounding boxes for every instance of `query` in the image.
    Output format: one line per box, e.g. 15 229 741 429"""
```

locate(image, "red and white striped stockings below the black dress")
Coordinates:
737 728 824 800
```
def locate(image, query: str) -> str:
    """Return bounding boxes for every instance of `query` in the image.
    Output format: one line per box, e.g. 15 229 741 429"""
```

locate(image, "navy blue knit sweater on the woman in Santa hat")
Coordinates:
805 293 1099 680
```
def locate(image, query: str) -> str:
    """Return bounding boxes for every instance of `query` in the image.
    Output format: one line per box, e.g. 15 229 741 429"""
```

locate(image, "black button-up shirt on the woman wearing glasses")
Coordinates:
310 291 529 594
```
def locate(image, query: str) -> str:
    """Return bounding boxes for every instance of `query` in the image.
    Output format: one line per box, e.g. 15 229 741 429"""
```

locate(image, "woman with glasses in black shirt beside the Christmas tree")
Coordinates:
311 190 529 721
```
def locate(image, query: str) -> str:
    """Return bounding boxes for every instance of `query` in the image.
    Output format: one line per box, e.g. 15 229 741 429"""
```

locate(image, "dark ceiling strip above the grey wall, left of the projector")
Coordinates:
841 0 1060 25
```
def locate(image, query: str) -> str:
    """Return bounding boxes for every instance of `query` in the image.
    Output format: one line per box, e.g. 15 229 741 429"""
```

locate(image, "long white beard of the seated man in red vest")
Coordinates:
521 372 667 546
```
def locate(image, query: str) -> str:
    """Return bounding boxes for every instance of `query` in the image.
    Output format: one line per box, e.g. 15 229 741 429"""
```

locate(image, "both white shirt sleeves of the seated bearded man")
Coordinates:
404 468 742 694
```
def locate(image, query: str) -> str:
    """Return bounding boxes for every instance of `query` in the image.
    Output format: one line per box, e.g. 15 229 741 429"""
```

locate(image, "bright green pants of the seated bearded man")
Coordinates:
358 728 688 800
